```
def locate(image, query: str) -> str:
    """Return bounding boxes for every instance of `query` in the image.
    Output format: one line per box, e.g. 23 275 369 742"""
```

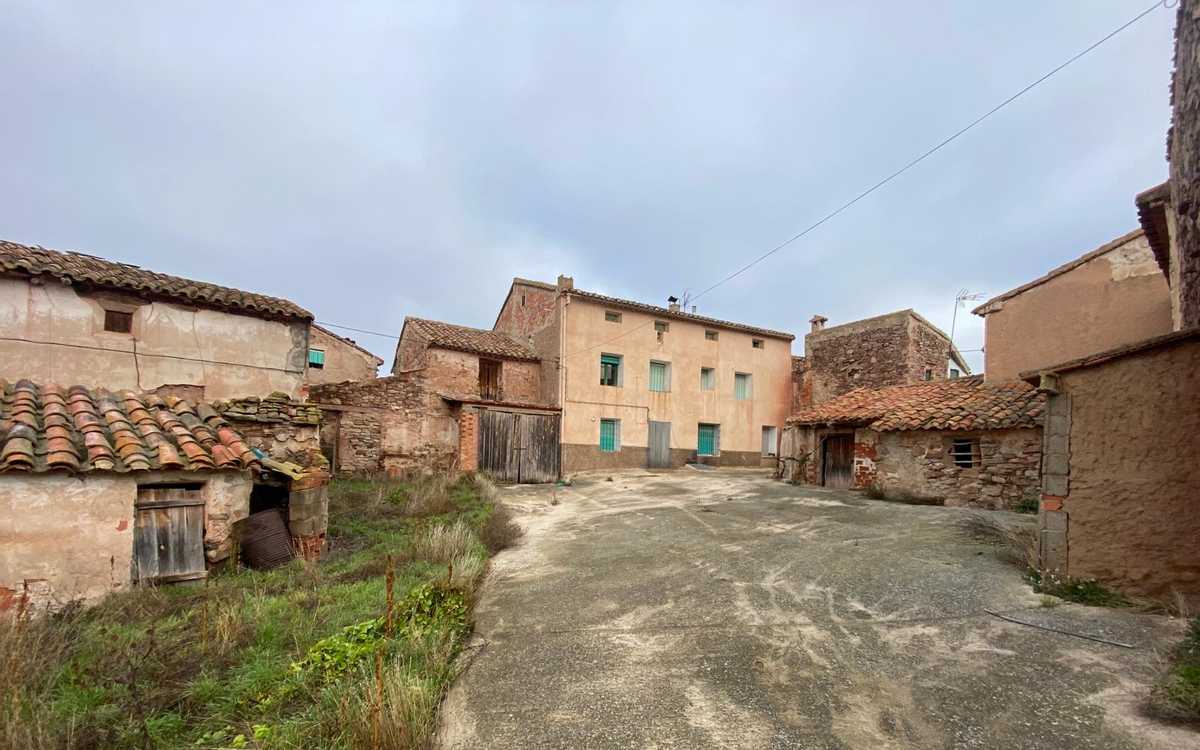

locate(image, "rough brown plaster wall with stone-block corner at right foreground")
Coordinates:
1043 340 1200 606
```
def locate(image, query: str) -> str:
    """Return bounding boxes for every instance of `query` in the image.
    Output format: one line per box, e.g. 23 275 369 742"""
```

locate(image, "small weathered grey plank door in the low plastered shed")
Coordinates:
133 487 208 583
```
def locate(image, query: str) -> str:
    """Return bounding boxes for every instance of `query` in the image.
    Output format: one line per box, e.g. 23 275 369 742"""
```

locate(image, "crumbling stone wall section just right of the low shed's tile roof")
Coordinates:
212 394 326 468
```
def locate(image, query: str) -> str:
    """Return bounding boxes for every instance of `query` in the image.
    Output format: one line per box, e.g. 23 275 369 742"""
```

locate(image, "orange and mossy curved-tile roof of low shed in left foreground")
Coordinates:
0 379 258 473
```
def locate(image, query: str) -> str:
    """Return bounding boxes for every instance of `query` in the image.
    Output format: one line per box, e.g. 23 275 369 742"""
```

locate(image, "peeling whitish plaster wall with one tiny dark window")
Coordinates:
0 277 308 398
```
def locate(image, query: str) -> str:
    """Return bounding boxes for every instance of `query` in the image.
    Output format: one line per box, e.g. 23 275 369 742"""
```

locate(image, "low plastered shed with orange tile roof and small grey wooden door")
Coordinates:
0 380 262 610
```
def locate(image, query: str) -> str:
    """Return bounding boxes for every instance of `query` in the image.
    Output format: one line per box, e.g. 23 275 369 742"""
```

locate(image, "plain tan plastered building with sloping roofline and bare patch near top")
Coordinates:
972 229 1171 382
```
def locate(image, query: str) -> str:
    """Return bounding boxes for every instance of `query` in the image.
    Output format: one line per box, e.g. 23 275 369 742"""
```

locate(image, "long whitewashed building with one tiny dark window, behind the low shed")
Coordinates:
0 241 312 402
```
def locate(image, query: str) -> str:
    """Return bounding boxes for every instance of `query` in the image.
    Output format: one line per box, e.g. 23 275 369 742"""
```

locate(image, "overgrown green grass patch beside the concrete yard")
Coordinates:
0 476 503 749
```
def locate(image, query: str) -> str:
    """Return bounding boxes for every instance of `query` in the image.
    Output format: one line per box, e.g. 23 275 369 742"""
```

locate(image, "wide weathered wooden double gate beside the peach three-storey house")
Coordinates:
478 409 558 484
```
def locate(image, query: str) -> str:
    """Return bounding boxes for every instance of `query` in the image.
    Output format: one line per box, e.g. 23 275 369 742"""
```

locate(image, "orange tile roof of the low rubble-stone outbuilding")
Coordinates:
787 376 1045 432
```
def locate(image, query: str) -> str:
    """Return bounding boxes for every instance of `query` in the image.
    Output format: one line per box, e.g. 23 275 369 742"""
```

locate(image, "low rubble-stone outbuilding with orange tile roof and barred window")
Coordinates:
781 376 1044 509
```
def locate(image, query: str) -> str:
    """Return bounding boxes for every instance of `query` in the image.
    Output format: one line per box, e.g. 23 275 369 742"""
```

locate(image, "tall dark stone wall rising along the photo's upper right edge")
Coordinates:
1169 0 1200 329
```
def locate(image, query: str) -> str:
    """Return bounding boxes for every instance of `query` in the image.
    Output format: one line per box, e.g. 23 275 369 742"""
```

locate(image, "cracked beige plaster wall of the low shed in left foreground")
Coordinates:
0 472 252 610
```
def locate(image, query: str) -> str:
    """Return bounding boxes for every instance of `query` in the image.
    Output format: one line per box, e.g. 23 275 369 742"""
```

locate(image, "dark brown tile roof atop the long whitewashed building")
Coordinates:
0 240 312 320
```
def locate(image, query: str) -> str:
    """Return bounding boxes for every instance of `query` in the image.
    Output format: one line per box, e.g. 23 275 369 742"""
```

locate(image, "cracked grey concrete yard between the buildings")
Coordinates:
438 469 1200 750
